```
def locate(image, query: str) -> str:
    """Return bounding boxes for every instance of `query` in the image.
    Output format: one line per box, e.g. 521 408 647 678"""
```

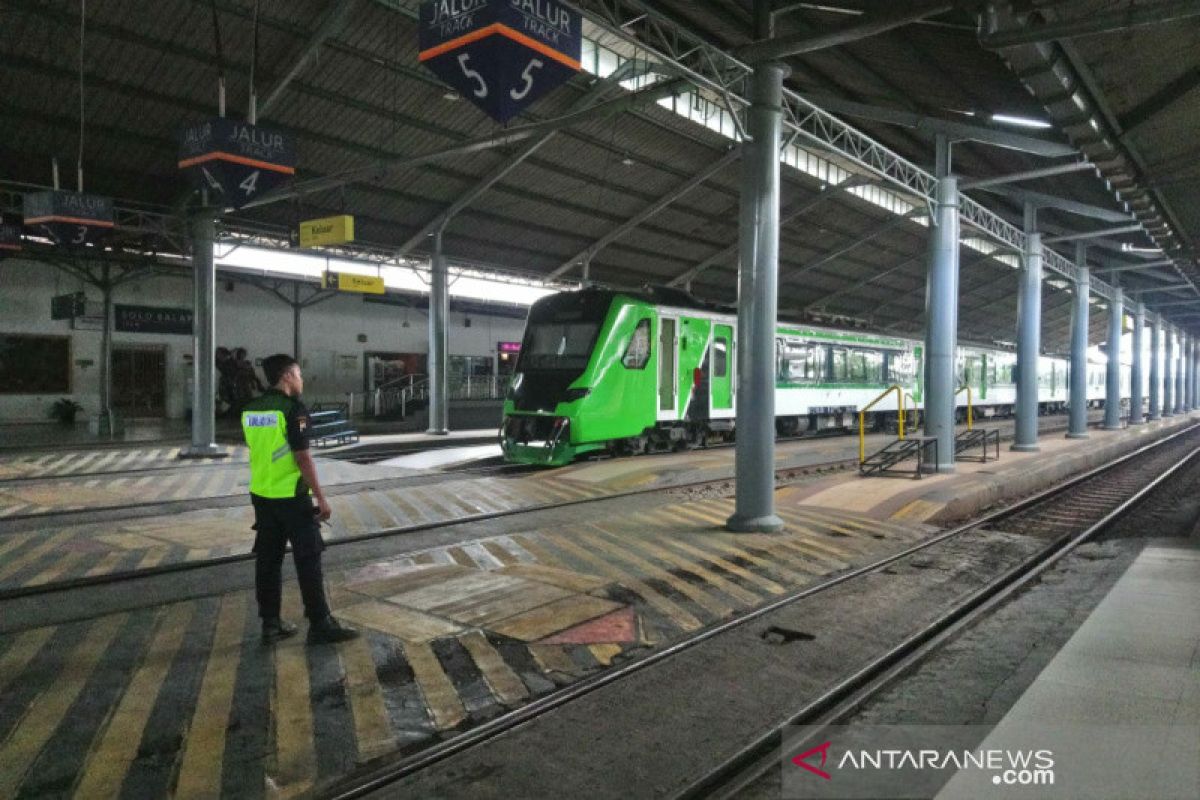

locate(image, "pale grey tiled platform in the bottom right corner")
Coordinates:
937 537 1200 800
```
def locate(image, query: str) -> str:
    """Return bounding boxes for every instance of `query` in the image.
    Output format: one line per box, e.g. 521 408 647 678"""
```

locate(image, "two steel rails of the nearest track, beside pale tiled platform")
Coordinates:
322 425 1200 800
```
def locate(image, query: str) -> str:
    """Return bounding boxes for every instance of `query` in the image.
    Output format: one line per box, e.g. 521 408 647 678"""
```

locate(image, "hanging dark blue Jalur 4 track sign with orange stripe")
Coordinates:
179 118 296 209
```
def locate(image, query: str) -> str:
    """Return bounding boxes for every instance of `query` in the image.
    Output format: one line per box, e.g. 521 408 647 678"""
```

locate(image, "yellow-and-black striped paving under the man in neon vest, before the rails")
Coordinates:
0 493 926 798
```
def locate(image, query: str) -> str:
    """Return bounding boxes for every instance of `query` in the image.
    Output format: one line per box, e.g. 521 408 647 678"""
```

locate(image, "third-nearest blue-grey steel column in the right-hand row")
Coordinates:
1012 206 1042 452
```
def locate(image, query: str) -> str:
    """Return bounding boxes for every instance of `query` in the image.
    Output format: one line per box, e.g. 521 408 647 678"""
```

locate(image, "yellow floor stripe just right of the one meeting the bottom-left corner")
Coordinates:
76 603 196 800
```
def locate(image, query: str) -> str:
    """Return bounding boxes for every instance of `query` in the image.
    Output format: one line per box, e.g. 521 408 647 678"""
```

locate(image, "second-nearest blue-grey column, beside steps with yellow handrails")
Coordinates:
925 142 959 473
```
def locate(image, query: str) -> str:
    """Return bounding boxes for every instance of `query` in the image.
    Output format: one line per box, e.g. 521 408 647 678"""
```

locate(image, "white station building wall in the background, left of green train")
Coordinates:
0 259 524 422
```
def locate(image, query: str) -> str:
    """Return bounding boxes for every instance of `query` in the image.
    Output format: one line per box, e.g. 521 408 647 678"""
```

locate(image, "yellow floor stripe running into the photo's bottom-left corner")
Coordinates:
0 614 127 798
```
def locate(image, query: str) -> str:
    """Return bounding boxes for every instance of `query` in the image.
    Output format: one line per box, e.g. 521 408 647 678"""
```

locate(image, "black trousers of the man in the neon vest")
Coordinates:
250 494 329 620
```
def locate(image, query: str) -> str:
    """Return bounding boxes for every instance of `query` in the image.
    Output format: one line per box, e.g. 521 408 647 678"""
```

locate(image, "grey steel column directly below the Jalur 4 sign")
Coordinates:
180 210 227 458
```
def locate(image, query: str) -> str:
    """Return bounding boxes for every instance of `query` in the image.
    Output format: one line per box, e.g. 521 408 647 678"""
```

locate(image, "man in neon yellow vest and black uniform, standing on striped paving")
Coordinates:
241 354 358 644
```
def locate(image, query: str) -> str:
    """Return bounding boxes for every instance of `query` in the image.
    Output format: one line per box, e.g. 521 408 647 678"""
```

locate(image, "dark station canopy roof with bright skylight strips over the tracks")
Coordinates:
0 0 1200 351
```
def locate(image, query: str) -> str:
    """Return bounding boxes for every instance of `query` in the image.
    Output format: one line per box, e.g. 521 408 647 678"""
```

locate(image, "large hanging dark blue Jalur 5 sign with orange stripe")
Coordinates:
420 0 583 122
